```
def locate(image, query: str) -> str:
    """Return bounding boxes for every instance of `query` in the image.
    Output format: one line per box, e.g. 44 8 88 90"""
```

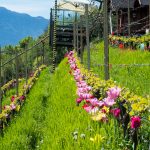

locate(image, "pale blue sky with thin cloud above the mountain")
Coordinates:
0 0 54 19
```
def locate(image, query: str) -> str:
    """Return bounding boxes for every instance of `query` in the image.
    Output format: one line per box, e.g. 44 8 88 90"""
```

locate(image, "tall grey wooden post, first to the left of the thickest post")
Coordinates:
85 4 90 70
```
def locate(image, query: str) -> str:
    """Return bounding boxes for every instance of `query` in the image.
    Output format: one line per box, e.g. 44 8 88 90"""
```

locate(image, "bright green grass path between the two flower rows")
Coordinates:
0 60 126 150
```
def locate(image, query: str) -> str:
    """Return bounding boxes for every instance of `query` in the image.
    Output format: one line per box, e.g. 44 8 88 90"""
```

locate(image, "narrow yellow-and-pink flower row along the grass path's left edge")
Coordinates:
0 65 46 128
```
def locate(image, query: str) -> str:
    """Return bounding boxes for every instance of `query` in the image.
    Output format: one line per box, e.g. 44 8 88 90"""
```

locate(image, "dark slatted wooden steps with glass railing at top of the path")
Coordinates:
50 9 85 49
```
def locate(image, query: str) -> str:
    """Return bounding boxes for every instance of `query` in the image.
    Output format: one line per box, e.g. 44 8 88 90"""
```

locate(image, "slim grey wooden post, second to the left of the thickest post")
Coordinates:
80 16 83 63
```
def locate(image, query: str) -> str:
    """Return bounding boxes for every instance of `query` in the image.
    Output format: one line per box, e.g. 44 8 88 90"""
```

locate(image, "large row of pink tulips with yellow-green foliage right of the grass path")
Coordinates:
67 51 148 149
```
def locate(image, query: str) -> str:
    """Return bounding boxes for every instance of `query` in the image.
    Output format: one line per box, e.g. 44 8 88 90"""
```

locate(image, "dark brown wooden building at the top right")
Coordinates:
111 0 150 35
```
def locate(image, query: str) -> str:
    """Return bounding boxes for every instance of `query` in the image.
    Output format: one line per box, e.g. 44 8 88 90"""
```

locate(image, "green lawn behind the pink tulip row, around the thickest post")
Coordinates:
84 42 150 96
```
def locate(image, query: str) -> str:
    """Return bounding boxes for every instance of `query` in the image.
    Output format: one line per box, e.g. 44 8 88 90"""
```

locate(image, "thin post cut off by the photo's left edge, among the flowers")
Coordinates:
0 46 3 132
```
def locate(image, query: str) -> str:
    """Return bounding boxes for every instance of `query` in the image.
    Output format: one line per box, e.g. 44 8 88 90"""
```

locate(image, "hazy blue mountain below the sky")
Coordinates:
0 7 49 46
